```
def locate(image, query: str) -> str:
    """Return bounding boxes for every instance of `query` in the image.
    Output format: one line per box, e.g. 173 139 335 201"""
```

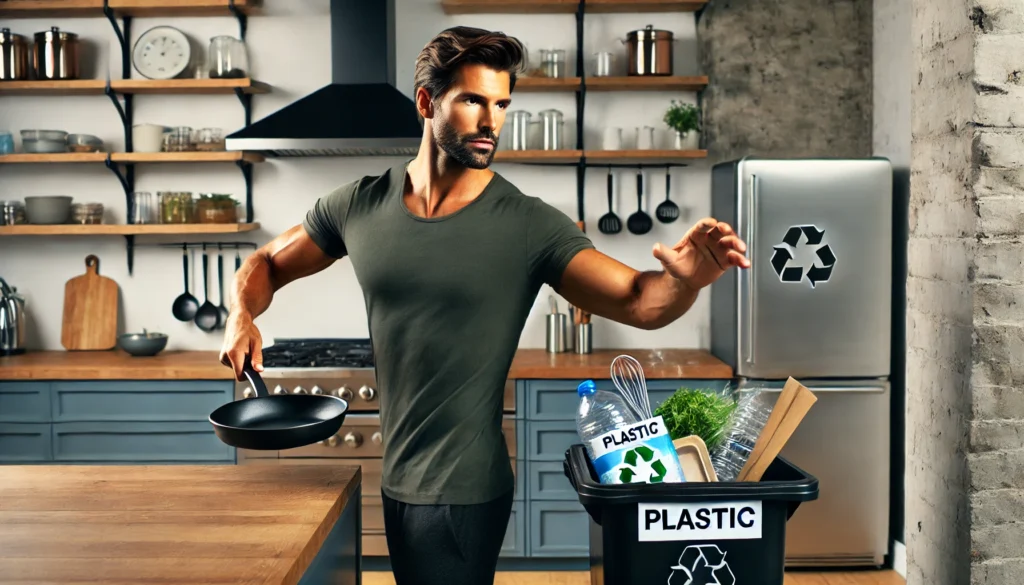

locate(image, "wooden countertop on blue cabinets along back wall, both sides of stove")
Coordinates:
0 349 732 380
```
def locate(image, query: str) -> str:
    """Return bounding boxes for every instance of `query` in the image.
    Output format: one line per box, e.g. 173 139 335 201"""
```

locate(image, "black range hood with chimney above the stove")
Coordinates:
226 0 423 157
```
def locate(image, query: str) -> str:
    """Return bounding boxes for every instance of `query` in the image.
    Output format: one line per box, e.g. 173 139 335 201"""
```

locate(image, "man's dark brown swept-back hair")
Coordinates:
414 27 526 99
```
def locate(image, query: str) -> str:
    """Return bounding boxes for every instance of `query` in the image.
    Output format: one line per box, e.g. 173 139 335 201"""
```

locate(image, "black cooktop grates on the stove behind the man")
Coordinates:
263 339 374 368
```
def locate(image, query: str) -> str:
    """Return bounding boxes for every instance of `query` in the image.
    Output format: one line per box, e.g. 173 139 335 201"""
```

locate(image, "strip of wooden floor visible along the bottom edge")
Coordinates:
362 571 906 585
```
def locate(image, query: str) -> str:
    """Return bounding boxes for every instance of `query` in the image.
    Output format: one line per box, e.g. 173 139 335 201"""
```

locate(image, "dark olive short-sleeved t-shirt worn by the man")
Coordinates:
303 163 593 504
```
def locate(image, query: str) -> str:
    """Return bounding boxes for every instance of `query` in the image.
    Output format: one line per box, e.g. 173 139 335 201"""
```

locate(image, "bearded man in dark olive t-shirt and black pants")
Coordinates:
221 27 750 585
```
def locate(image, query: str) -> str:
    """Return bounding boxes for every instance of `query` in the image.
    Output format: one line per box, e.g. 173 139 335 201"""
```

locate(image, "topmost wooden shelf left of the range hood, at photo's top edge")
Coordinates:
0 0 262 19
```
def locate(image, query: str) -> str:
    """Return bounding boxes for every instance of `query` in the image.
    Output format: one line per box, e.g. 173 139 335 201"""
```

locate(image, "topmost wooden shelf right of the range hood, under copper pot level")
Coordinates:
441 0 708 14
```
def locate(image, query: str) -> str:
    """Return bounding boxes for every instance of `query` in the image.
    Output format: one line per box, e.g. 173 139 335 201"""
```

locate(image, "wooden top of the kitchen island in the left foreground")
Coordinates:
0 465 361 585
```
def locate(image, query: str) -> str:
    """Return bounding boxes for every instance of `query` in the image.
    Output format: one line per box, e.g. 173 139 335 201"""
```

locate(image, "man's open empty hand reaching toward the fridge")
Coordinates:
653 217 751 291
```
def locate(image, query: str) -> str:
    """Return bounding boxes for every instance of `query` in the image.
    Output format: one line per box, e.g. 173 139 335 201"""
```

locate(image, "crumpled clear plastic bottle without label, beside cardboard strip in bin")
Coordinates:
711 389 775 482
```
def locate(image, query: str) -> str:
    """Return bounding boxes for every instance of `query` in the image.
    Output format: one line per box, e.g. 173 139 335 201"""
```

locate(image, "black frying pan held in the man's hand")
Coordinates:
210 356 348 451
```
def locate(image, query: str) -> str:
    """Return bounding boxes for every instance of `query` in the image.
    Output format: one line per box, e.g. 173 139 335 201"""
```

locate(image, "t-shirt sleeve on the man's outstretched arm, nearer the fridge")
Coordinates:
526 199 594 287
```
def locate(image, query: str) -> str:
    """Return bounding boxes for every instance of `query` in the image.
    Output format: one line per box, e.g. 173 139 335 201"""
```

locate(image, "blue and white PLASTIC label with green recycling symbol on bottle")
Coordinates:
590 416 685 484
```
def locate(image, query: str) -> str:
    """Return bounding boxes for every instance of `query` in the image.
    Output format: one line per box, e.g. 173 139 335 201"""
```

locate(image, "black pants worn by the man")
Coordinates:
384 490 515 585
